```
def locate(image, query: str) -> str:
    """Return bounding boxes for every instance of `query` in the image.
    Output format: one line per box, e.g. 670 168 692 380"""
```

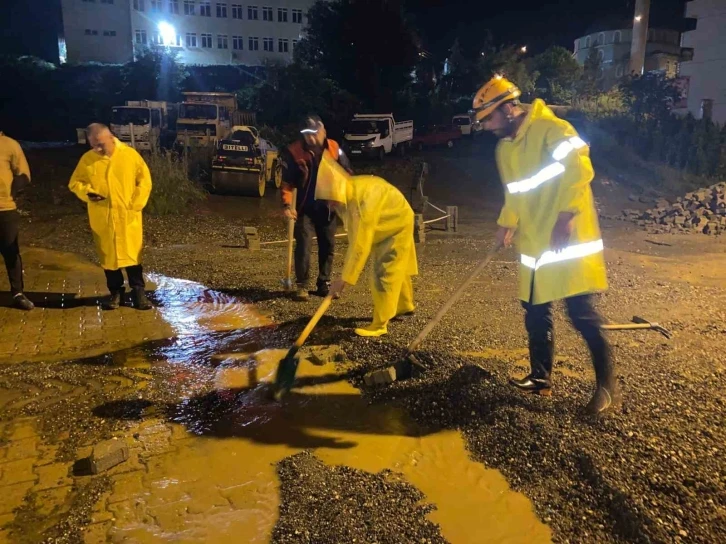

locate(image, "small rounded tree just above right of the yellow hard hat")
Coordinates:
530 46 583 104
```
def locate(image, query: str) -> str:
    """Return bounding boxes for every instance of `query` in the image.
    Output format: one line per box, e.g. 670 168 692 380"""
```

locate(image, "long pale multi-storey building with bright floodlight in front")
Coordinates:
60 0 314 66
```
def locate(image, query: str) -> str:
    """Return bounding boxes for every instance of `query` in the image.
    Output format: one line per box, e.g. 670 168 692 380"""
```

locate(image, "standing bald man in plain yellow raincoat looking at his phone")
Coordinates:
68 123 151 310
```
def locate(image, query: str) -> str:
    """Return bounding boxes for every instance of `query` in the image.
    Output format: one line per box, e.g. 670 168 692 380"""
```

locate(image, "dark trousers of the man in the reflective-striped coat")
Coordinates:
522 295 615 387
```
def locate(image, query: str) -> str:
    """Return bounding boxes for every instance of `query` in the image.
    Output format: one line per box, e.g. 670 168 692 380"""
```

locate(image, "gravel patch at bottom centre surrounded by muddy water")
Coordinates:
272 452 446 544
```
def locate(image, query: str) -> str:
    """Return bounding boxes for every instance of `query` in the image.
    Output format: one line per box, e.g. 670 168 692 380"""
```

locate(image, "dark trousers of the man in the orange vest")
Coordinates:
295 207 338 288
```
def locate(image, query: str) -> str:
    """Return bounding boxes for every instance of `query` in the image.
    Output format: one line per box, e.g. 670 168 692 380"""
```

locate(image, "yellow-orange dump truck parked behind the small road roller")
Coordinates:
176 92 255 147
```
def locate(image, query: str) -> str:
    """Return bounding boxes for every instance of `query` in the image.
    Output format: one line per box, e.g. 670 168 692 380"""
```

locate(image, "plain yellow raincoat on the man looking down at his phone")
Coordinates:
68 139 151 270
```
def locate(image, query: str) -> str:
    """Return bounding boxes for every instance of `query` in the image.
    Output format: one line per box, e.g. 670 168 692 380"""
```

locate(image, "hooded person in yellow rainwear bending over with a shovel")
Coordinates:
315 151 418 336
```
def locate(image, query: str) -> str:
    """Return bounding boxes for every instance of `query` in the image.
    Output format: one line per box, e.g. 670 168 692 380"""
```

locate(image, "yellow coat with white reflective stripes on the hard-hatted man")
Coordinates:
496 100 607 304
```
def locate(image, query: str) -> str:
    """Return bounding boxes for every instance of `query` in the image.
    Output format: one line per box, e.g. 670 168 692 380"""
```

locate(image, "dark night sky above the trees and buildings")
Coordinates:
0 0 684 60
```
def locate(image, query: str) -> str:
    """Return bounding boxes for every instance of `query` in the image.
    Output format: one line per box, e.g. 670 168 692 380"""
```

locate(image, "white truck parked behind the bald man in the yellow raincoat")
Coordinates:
111 100 169 151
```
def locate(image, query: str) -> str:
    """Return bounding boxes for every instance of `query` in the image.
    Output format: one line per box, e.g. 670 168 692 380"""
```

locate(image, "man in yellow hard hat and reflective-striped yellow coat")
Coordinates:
473 76 620 414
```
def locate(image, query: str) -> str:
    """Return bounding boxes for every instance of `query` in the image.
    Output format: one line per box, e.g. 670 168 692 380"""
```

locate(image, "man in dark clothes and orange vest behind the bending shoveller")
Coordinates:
281 115 352 301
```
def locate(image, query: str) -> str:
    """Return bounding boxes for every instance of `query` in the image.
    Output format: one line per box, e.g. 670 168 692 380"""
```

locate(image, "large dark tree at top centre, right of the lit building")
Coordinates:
295 0 420 111
